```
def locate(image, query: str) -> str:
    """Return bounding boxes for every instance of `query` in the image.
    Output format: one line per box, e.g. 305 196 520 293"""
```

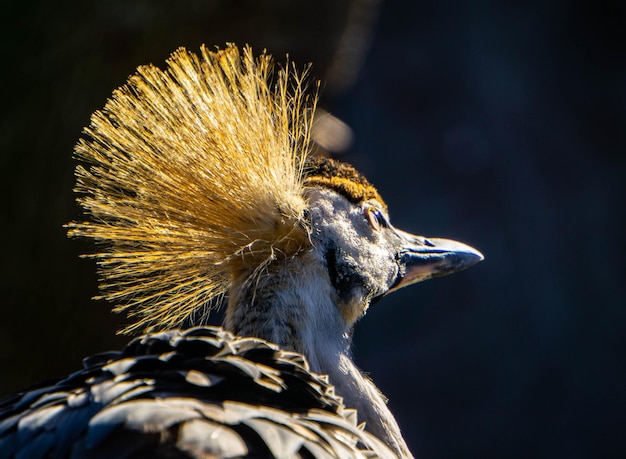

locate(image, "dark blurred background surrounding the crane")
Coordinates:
0 0 626 458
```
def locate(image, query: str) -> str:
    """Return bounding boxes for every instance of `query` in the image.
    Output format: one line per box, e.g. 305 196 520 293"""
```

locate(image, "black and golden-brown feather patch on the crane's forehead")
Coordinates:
303 158 387 210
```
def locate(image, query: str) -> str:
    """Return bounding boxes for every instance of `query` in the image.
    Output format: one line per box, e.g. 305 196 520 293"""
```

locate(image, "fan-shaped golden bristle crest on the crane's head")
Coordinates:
67 45 316 333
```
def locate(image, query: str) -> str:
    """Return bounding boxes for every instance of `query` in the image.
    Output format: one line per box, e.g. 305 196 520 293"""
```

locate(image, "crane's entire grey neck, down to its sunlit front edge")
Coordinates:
224 260 413 458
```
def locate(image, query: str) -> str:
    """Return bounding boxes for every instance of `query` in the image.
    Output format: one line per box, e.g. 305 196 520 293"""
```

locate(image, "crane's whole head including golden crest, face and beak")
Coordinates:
69 46 482 340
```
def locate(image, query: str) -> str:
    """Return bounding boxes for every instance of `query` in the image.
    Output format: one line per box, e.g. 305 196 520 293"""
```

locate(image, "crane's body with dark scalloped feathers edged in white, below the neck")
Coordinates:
0 327 393 458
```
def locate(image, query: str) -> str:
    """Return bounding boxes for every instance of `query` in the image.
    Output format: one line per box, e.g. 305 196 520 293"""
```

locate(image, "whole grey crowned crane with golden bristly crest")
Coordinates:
0 44 483 458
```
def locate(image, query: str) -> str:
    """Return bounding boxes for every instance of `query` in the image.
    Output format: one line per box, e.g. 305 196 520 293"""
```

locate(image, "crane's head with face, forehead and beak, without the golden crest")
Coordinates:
305 158 483 327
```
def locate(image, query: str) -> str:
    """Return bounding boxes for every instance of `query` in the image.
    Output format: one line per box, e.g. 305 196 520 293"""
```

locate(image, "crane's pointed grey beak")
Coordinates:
387 228 484 293
